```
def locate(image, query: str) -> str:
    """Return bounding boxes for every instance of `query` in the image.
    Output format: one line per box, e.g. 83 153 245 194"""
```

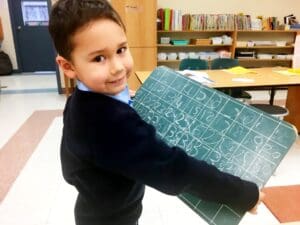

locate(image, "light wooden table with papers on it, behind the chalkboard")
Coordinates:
135 67 300 131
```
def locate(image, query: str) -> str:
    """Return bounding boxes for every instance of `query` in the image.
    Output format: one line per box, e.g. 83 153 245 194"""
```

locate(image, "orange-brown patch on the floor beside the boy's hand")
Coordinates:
263 185 300 223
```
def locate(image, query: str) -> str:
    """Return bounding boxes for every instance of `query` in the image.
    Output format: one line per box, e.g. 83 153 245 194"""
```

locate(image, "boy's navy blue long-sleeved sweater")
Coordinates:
61 89 258 225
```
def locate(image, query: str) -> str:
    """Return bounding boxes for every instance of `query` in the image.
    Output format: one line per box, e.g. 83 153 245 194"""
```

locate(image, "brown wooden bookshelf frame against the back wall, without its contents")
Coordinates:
157 30 299 69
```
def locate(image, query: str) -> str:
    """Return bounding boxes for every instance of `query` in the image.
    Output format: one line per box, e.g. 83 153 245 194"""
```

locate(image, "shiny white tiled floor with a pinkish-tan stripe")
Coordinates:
0 74 300 225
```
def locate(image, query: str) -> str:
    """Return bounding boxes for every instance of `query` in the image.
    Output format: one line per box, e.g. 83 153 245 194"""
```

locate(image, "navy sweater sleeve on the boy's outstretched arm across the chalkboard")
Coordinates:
88 107 258 211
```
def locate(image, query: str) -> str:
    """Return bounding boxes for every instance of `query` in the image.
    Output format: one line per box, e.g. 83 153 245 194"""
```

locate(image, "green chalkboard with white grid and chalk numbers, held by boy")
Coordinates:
134 66 296 225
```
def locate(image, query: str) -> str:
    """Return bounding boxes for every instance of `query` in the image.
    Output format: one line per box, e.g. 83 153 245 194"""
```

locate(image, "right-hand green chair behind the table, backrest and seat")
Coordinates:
210 58 251 101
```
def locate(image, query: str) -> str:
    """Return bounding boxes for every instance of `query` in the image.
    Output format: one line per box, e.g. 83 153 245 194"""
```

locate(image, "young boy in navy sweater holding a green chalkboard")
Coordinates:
49 0 262 225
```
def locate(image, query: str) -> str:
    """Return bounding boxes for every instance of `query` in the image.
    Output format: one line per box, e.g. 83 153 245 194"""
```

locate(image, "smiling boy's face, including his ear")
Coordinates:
57 19 133 95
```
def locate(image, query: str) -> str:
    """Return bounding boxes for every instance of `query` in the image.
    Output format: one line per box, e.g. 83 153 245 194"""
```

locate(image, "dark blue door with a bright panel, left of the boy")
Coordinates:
8 0 56 72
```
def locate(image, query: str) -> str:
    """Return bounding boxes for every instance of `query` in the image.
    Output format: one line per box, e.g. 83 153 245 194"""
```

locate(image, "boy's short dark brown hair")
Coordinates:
49 0 125 60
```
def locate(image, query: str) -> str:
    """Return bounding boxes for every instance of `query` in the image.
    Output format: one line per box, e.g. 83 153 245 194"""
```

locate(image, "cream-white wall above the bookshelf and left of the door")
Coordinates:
0 0 300 69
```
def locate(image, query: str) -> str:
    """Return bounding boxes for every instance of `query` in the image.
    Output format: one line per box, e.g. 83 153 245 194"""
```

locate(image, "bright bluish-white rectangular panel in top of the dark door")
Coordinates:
21 1 49 26
